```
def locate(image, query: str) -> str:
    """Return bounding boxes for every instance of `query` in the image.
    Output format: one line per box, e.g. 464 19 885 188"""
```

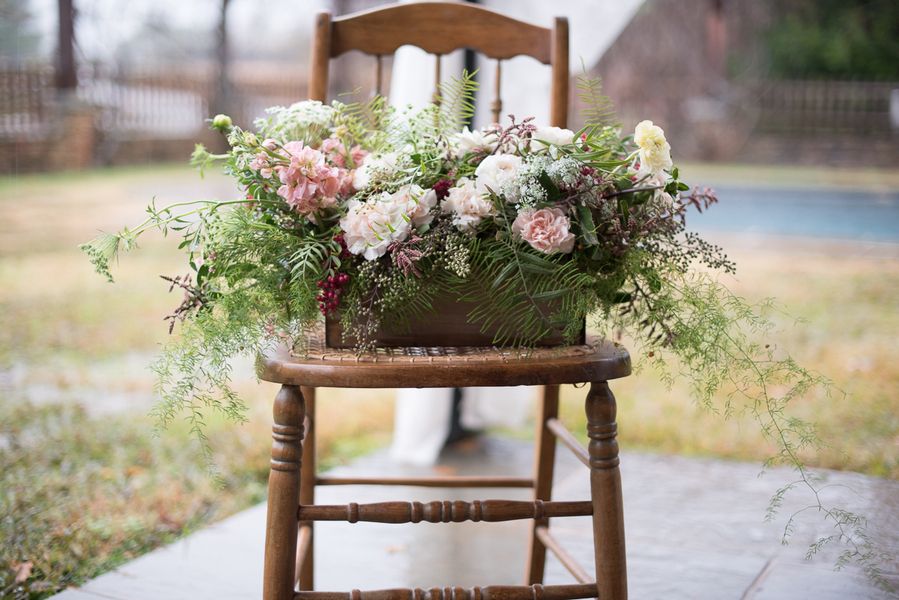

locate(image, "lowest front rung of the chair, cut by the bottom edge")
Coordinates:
293 583 596 600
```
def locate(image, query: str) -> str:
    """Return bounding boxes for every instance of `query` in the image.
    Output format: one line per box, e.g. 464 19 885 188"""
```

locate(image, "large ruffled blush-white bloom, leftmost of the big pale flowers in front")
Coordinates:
340 194 411 260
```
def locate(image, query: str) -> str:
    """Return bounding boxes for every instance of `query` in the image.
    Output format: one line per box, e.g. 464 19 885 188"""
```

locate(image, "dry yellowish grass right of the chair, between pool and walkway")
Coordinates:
563 234 899 479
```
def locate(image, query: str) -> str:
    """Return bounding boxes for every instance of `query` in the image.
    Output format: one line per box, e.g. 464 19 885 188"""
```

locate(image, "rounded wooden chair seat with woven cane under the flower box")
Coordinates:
259 331 631 388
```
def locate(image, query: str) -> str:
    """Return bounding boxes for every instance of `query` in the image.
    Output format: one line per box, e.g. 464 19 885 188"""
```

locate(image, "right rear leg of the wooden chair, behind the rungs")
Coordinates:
525 385 559 585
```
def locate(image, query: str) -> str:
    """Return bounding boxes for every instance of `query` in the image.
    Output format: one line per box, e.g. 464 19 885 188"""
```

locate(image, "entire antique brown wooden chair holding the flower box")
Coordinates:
260 2 630 600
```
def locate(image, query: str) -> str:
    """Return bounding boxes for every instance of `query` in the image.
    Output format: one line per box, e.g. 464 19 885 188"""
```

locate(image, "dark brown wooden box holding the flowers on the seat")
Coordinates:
325 296 585 348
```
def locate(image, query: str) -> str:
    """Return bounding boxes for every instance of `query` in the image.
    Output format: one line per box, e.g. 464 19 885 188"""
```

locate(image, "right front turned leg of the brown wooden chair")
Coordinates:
586 381 627 600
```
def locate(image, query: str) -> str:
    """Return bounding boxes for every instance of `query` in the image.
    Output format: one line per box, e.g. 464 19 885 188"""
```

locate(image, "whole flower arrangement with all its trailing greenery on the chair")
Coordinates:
83 75 879 580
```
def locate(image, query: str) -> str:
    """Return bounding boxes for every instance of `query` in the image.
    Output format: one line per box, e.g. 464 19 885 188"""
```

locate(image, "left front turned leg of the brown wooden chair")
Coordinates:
262 385 306 600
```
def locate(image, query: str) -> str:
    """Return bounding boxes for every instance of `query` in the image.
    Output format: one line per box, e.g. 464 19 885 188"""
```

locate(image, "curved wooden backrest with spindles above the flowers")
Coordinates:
309 2 568 127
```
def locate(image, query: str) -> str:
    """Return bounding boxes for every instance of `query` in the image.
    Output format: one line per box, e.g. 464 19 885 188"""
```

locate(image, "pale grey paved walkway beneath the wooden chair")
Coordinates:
54 439 899 600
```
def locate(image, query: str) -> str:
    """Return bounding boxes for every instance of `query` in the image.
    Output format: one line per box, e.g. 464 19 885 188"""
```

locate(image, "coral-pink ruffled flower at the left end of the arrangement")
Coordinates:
277 142 347 215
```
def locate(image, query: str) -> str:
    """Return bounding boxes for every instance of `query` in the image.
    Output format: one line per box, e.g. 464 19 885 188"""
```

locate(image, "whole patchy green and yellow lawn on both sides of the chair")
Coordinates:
0 165 899 598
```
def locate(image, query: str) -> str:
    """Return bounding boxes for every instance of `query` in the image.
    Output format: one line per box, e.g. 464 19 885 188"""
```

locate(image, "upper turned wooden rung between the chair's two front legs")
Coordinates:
297 500 593 523
